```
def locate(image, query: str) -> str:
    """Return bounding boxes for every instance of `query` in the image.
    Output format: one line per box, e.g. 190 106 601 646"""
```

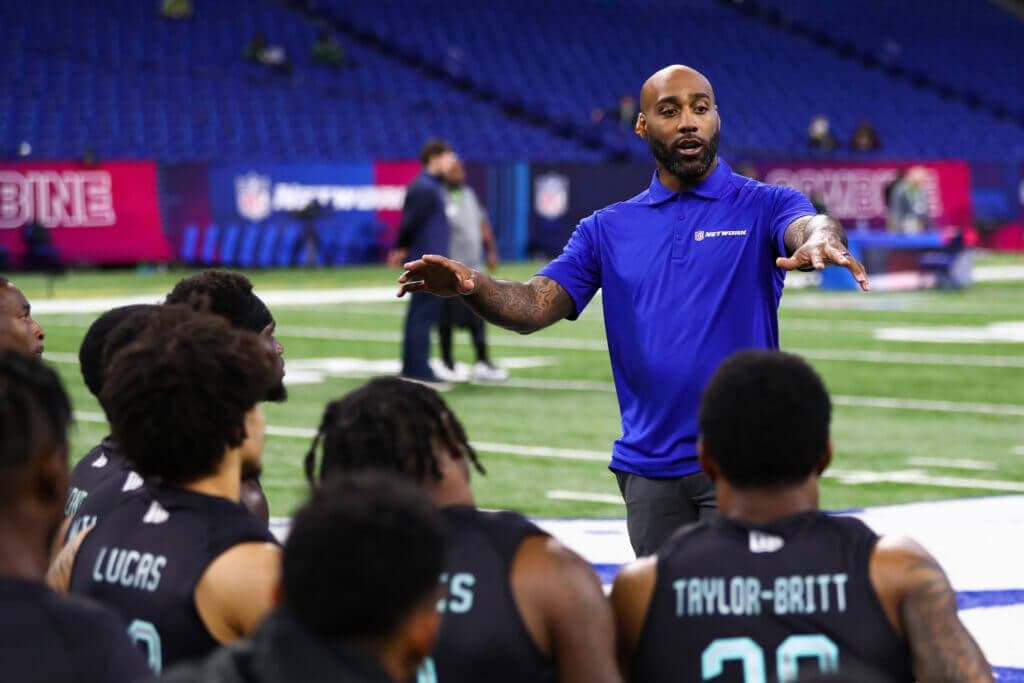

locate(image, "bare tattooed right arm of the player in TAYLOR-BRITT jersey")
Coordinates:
870 537 992 683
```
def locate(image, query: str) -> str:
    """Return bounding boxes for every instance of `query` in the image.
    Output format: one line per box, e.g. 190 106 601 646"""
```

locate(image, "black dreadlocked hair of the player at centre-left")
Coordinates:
304 377 486 486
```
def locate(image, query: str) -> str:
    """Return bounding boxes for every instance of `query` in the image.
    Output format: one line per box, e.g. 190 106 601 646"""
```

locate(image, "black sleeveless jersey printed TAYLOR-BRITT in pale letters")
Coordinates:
632 511 913 683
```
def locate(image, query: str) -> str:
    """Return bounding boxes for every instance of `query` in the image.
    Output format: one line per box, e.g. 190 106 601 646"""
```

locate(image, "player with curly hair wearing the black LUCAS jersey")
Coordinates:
55 305 281 671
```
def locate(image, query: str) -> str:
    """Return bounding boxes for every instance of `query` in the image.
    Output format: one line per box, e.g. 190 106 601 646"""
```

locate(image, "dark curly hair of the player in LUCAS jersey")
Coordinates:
100 305 275 484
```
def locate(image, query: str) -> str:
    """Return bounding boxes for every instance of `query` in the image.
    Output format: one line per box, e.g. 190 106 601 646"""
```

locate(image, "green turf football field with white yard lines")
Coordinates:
14 250 1024 516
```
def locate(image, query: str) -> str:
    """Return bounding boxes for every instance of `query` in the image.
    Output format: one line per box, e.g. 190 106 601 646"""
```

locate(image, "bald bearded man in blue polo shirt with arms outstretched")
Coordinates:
398 66 867 555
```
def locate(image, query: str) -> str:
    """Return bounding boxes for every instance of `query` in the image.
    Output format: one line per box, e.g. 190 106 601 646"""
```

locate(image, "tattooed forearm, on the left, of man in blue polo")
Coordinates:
465 275 574 334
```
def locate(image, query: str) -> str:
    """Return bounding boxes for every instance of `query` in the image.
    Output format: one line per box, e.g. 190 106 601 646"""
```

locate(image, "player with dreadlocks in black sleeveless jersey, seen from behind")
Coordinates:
306 377 622 683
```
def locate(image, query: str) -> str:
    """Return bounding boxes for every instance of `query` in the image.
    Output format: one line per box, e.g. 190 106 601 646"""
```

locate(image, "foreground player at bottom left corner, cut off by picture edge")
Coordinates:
0 350 147 683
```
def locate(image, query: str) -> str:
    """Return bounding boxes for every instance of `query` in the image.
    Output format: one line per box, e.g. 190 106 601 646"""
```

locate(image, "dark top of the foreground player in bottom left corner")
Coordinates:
0 579 150 683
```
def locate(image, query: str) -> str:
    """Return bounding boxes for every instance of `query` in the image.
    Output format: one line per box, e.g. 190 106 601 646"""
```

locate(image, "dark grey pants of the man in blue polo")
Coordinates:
615 470 718 557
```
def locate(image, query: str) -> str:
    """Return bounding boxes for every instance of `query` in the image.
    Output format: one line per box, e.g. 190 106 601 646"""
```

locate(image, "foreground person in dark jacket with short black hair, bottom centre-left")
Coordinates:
160 473 444 683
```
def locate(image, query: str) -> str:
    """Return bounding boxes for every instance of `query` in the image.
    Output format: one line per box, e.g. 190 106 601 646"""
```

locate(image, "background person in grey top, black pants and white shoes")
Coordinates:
437 159 508 382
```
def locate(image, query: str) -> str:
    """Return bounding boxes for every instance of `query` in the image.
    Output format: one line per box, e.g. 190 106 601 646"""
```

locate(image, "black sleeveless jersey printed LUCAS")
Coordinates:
71 484 276 672
